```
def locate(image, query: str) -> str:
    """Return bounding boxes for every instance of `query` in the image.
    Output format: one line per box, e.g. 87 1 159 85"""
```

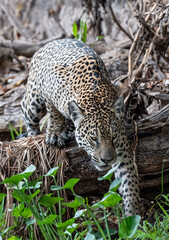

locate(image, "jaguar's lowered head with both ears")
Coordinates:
69 98 123 171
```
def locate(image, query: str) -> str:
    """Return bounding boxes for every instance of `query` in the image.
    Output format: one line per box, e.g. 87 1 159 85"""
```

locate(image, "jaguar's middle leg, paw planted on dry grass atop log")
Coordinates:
46 102 68 148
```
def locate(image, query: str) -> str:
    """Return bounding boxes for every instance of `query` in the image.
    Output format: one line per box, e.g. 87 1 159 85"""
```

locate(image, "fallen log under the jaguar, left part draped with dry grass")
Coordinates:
0 105 169 200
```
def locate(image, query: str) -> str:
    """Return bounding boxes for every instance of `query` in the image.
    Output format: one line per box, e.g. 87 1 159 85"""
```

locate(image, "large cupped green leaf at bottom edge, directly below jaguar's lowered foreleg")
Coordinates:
118 215 141 239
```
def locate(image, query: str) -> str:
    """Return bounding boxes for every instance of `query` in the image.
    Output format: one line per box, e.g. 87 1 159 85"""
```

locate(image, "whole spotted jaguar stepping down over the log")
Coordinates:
21 39 139 216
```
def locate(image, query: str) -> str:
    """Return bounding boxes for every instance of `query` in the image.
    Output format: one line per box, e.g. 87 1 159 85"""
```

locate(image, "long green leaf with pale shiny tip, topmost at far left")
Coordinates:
2 164 36 186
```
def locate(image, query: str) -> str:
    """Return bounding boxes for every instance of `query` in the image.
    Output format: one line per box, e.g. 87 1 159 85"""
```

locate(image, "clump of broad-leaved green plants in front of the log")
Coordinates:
0 165 140 240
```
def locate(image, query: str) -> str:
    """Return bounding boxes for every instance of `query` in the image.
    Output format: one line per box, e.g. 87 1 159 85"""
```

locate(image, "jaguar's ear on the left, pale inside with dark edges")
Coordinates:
68 101 84 127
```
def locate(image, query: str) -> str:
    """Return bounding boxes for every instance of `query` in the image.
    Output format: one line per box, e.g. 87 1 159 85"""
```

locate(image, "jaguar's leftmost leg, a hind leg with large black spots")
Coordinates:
21 94 46 136
